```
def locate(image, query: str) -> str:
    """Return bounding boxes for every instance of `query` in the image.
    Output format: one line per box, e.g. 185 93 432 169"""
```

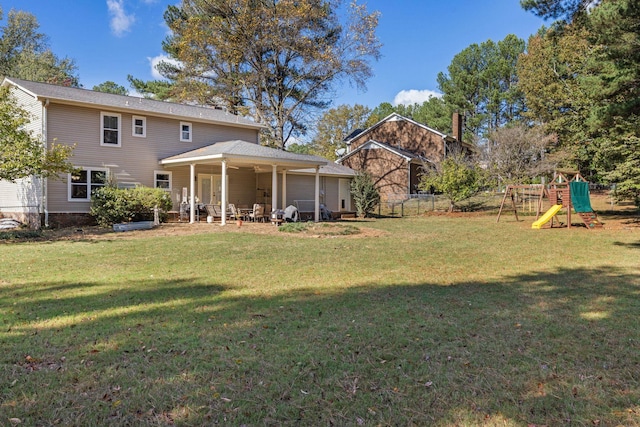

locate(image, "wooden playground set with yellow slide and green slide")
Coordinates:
496 173 602 230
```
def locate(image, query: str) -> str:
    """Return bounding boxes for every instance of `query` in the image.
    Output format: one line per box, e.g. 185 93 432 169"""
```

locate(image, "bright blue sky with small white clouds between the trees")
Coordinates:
0 0 545 108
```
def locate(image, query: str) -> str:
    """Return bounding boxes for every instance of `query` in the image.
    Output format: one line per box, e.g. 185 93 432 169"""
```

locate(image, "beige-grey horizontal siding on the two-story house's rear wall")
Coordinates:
47 104 258 213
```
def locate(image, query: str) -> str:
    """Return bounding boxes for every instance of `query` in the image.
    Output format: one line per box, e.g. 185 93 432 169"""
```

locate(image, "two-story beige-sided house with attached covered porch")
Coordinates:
0 78 353 226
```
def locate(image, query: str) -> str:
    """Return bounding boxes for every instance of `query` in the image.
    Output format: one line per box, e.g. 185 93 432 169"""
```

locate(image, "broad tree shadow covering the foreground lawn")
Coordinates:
0 267 640 425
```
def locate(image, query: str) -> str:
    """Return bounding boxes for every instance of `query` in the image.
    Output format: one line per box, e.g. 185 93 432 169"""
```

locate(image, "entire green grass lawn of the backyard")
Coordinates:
0 216 640 426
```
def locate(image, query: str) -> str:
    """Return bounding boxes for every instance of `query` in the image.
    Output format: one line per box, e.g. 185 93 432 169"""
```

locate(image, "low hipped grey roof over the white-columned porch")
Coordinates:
160 140 328 168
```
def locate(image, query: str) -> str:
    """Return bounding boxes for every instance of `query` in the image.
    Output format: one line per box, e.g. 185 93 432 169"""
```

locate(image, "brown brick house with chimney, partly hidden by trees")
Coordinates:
337 113 472 200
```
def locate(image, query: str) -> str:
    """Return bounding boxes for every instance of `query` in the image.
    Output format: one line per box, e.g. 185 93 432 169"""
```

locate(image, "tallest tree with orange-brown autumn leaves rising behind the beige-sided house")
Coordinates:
149 0 380 148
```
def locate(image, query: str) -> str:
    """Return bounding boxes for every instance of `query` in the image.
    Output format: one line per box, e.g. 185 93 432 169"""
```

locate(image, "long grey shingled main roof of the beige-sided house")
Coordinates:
2 78 264 129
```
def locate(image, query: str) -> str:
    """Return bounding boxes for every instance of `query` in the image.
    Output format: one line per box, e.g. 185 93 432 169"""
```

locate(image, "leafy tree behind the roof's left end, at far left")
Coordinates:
0 9 79 87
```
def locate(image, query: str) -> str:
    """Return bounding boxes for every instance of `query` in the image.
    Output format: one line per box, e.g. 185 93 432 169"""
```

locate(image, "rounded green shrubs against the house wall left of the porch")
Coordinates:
91 186 173 227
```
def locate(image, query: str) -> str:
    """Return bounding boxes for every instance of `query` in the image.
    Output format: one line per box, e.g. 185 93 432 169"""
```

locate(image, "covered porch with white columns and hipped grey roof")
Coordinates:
159 140 329 225
